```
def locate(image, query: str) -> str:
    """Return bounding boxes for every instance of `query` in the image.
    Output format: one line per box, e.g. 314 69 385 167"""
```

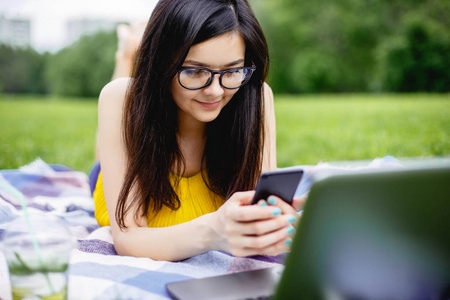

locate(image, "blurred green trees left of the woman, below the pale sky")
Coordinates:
0 32 117 97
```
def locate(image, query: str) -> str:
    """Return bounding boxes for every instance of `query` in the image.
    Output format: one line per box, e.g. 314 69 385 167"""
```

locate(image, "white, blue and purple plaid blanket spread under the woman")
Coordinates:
0 159 284 300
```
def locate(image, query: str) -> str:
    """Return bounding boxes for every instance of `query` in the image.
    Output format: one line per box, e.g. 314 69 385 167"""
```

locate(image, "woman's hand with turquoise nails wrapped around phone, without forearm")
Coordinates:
211 191 298 256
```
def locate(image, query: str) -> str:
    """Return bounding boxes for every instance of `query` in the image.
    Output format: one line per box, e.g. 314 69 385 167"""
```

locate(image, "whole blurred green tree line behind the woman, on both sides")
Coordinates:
0 0 450 98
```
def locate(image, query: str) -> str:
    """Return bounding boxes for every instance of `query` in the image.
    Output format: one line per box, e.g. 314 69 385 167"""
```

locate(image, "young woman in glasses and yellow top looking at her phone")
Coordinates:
94 0 300 261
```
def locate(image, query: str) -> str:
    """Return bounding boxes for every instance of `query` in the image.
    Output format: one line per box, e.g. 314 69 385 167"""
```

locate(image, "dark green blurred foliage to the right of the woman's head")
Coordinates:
252 0 450 93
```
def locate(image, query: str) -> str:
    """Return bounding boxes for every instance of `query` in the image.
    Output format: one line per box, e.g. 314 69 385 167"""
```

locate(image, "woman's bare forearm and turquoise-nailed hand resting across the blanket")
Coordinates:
111 191 296 261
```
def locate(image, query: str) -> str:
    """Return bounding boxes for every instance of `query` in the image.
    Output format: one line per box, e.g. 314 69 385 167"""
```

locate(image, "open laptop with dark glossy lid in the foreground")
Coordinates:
166 163 450 300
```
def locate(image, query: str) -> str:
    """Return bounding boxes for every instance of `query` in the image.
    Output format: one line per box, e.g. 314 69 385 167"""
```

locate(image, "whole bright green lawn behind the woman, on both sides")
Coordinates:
0 94 450 172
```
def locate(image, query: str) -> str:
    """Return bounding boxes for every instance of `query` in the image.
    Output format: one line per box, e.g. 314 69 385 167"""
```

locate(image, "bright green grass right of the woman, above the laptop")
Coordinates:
275 94 450 167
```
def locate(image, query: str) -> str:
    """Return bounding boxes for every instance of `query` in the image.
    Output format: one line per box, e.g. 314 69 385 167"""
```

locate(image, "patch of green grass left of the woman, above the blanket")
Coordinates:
0 96 97 172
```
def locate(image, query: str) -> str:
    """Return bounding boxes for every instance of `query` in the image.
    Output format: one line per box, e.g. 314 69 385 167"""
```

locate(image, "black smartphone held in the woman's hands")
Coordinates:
252 169 303 204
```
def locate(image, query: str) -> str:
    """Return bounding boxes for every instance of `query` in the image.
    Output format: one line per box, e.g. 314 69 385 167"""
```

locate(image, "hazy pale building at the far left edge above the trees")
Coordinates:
0 15 31 47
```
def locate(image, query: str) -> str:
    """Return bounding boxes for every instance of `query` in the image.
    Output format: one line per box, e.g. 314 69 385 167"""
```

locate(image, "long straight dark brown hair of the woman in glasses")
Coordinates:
116 0 269 228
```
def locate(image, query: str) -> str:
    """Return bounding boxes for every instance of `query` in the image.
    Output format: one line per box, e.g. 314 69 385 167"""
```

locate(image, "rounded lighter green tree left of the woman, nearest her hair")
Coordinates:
46 32 117 97
